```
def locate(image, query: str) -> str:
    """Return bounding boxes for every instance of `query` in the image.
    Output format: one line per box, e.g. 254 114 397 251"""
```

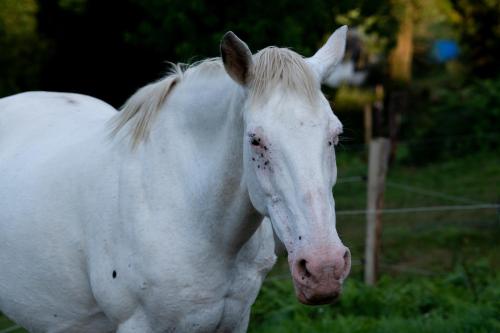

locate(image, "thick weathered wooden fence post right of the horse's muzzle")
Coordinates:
365 138 390 285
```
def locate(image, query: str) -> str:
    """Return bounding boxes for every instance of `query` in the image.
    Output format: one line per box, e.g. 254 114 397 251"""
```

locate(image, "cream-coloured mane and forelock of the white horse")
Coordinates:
111 47 319 147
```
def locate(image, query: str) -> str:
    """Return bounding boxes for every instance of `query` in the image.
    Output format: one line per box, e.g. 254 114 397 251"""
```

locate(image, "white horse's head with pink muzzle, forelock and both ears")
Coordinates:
221 26 351 304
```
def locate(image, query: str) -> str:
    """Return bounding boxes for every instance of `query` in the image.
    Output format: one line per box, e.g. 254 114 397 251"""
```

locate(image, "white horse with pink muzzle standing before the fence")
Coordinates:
0 27 350 333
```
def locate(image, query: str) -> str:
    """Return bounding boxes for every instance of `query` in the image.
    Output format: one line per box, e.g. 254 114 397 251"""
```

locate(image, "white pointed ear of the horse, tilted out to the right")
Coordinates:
306 25 347 82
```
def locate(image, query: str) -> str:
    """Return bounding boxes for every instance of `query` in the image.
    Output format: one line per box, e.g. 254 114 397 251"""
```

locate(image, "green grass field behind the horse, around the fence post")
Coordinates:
0 149 500 333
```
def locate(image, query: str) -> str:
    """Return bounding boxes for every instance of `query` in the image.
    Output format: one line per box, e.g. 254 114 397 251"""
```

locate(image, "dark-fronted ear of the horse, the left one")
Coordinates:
220 31 252 85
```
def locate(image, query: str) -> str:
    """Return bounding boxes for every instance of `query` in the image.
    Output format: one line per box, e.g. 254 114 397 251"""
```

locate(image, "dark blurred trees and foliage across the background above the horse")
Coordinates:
0 0 500 162
